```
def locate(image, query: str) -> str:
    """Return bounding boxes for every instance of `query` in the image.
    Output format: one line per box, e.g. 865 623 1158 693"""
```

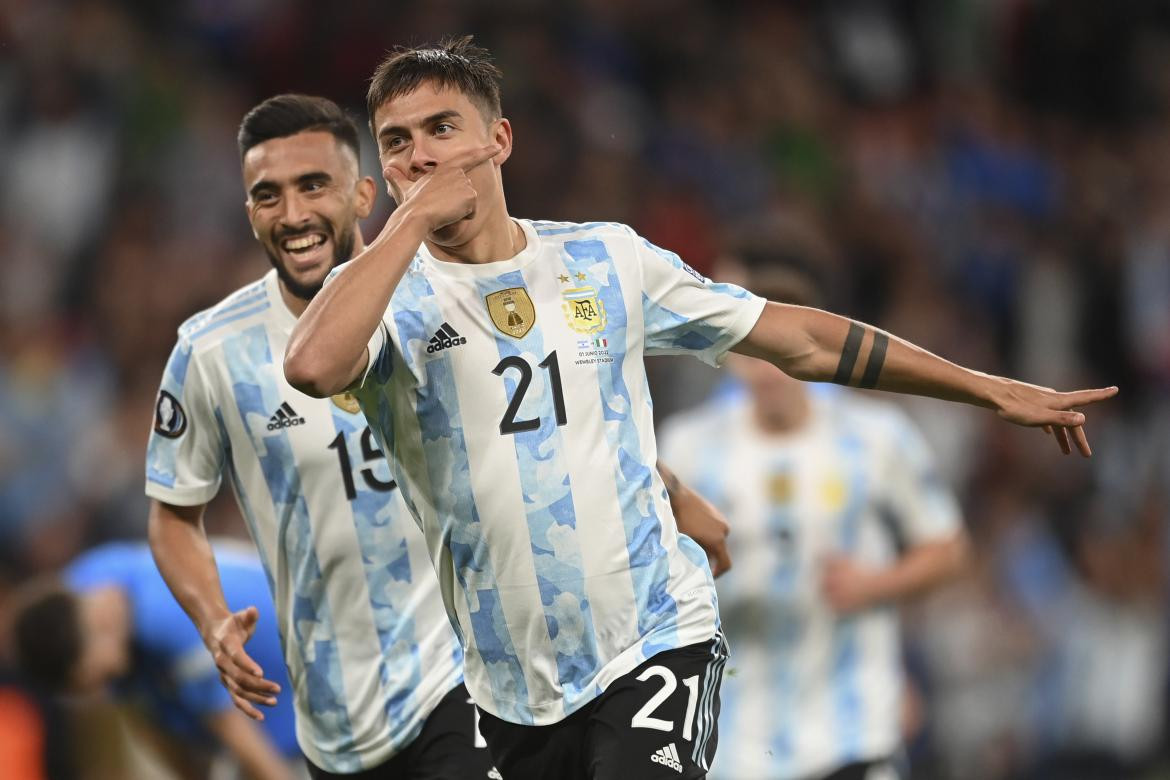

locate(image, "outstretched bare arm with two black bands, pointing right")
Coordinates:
735 303 1117 457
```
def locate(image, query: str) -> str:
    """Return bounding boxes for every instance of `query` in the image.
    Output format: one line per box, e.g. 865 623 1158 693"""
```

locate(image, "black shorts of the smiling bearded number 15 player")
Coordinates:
309 683 498 780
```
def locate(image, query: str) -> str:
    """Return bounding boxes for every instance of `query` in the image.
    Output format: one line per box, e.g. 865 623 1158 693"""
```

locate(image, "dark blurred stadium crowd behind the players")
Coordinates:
0 0 1170 780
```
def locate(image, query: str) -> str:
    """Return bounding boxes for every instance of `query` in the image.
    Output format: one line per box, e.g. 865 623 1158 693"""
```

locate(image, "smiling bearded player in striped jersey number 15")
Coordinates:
146 95 491 780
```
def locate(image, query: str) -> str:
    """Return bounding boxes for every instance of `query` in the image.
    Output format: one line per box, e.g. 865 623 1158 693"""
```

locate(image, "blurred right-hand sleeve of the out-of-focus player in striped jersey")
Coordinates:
883 413 962 546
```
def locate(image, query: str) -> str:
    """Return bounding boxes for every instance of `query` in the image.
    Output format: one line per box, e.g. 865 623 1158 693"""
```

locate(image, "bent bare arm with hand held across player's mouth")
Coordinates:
284 144 500 398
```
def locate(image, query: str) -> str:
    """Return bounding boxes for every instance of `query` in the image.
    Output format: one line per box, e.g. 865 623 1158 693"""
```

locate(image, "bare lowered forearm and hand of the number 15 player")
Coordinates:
147 501 281 720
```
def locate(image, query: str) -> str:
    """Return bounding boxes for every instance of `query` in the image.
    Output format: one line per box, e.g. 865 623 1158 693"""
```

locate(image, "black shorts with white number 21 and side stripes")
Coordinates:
480 634 728 780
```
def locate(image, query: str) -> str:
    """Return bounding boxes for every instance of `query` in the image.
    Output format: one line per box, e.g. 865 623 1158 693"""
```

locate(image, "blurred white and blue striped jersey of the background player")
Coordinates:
662 386 959 780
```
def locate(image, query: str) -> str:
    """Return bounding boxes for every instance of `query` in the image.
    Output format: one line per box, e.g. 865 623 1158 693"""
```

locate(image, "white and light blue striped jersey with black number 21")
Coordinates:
346 220 764 725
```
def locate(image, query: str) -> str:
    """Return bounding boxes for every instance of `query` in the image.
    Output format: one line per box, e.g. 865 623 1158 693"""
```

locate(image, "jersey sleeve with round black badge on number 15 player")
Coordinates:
146 337 227 506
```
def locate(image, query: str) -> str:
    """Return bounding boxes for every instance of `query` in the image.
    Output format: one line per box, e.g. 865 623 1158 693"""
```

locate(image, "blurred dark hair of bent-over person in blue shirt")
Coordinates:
12 580 84 691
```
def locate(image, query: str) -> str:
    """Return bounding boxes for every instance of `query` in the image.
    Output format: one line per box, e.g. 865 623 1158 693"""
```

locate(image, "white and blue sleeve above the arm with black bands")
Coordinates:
634 230 768 366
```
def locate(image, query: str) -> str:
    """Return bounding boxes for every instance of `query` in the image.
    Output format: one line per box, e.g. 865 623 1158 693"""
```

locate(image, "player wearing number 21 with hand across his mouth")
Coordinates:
284 39 1115 780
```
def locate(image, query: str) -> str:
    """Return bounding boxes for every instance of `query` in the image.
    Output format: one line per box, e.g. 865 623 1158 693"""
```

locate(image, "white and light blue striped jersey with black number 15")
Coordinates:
146 271 462 773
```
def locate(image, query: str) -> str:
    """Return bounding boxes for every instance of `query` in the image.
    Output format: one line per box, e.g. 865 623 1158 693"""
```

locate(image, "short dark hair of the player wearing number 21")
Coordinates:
366 35 503 134
